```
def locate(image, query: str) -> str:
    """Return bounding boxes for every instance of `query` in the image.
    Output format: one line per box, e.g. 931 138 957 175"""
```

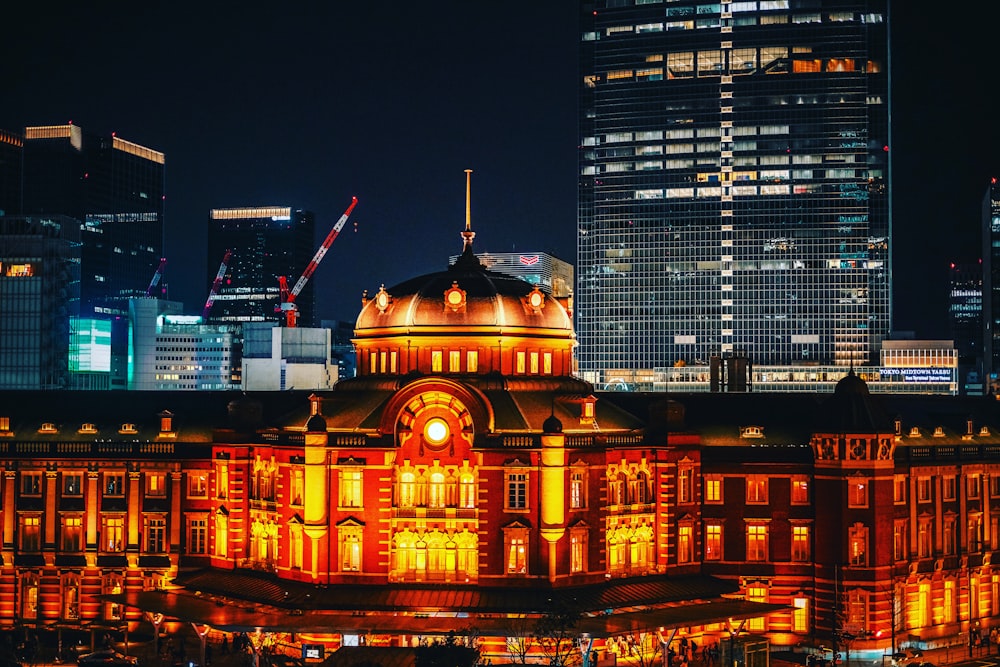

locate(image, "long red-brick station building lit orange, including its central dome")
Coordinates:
0 213 1000 662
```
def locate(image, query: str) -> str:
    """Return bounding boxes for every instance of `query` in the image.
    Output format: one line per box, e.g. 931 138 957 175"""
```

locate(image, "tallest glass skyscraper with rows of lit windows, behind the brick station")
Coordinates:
575 0 890 383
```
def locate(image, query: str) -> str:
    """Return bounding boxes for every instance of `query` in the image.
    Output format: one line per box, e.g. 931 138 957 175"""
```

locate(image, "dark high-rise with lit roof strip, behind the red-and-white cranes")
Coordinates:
206 206 315 326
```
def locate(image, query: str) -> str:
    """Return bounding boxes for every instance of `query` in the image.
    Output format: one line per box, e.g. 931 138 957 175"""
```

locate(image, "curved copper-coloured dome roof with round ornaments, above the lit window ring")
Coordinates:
355 243 573 338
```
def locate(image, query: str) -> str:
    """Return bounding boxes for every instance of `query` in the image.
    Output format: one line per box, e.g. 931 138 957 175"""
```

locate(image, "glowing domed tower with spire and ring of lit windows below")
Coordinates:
354 172 576 379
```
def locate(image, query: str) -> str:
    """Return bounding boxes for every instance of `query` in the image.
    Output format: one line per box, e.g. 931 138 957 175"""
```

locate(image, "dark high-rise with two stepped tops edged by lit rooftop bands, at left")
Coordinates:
22 124 165 315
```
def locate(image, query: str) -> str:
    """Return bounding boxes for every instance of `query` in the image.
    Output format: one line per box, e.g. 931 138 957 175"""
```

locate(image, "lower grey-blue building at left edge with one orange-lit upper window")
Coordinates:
0 216 80 389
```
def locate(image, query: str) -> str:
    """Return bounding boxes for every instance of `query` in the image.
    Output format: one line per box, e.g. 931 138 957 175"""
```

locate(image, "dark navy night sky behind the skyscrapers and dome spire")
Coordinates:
0 0 1000 337
